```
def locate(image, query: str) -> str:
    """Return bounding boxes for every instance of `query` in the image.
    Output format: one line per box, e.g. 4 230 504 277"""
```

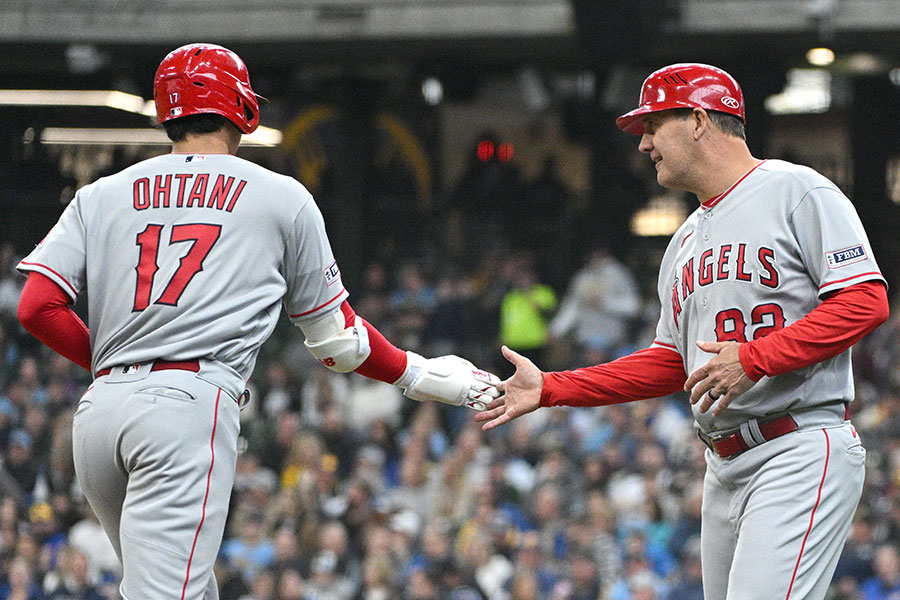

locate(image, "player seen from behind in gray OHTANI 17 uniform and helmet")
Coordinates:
18 44 498 600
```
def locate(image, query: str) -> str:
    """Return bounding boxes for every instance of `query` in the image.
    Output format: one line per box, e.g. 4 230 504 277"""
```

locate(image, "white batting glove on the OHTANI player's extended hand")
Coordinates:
394 351 500 411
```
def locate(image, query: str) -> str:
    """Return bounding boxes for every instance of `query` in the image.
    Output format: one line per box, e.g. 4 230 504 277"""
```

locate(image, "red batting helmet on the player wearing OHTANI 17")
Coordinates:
153 44 265 133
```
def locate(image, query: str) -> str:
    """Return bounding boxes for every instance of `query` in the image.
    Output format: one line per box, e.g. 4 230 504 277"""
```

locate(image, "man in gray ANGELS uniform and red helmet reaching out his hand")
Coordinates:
475 64 888 600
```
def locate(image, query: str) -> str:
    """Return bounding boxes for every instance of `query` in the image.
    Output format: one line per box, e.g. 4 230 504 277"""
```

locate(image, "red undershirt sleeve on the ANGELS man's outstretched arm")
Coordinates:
541 346 687 406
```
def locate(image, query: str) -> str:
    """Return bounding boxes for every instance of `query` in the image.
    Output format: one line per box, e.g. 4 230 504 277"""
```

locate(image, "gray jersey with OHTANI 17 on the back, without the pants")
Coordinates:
19 154 347 393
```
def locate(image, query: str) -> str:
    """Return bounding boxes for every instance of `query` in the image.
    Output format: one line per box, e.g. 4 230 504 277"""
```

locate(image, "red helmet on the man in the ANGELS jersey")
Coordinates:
616 63 744 135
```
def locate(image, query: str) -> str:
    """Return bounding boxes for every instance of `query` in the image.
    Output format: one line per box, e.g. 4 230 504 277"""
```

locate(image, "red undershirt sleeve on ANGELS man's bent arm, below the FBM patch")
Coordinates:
739 281 889 381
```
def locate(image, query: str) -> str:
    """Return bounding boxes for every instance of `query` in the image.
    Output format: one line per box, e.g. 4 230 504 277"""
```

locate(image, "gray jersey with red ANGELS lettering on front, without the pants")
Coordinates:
655 160 884 432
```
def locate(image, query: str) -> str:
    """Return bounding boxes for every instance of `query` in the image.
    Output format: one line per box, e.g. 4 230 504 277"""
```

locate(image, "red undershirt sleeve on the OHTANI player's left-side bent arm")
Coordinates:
17 271 91 371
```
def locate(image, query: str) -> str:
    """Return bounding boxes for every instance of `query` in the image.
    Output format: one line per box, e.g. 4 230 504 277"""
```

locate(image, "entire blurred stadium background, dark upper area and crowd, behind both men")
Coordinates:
0 0 900 600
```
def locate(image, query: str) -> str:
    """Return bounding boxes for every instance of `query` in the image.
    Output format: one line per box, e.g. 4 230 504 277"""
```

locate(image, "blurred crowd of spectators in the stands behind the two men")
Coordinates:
0 230 900 600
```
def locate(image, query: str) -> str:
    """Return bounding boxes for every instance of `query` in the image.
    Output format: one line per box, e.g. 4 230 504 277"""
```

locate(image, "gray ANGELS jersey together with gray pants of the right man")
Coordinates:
654 160 884 600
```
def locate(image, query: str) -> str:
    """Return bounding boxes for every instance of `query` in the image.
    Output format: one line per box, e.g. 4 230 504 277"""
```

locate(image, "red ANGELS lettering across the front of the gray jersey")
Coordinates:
672 243 781 328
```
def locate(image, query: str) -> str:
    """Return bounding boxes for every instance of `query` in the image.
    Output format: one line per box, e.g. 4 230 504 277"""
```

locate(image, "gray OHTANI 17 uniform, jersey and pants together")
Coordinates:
19 154 347 600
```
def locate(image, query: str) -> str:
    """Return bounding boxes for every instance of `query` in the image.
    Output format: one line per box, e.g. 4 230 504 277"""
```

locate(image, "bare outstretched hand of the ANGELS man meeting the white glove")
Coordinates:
475 346 544 431
